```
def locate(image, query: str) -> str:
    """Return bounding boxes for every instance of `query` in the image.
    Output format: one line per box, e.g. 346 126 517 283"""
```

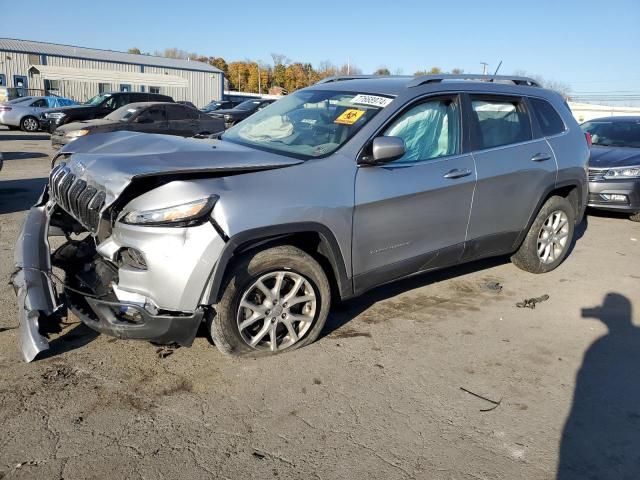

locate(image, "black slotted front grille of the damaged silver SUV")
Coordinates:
49 162 106 232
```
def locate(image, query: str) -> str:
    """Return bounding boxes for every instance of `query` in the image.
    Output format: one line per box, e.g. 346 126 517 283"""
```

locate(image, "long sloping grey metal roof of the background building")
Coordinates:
0 38 222 73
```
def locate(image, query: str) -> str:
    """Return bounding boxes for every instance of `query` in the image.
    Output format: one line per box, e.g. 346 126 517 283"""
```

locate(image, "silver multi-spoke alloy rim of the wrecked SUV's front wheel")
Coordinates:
237 270 317 352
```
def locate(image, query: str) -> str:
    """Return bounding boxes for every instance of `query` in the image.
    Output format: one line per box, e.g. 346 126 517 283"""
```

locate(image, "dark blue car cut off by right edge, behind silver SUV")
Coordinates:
581 117 640 222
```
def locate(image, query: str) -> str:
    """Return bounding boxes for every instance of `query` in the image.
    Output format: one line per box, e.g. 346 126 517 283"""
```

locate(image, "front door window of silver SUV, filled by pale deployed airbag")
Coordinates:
384 98 460 162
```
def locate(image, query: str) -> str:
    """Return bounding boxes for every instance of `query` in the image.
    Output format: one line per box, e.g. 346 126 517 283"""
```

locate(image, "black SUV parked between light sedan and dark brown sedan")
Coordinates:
40 92 173 132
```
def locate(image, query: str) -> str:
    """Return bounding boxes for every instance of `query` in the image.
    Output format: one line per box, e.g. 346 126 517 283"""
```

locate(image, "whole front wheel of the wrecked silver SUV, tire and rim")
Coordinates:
207 245 331 356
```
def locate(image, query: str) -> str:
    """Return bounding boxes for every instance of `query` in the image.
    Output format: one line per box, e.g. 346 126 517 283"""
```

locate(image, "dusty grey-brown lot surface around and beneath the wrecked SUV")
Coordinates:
0 130 640 480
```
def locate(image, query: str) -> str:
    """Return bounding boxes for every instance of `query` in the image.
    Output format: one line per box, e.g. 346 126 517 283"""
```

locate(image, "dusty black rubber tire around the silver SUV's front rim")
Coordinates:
206 245 331 357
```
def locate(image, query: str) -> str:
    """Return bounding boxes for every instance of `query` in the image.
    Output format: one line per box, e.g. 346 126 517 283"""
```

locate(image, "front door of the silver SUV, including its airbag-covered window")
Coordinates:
352 95 475 293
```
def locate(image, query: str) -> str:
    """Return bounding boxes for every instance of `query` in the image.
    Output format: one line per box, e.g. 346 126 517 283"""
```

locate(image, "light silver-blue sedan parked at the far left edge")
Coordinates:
0 96 76 132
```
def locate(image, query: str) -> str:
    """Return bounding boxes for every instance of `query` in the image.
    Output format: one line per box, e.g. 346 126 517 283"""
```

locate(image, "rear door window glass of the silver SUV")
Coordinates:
471 95 532 149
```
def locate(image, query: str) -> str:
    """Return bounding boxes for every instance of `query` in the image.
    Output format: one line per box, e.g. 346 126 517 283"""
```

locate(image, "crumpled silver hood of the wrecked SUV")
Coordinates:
59 131 302 207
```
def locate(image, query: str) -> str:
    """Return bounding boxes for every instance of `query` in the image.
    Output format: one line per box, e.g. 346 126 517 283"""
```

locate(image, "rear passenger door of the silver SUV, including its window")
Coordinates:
464 95 557 259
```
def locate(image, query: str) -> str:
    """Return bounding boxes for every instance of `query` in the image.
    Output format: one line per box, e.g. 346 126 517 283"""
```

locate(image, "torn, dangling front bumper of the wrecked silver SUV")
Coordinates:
11 191 204 362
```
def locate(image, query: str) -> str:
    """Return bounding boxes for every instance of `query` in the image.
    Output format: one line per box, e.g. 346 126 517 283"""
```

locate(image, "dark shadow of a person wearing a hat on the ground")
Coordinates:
556 293 640 480
